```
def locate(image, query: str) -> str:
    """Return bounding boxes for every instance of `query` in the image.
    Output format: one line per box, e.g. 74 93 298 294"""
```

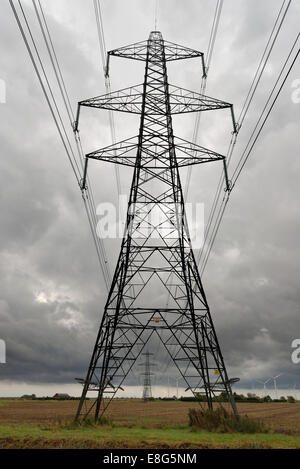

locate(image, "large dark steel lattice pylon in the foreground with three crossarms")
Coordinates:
74 31 237 418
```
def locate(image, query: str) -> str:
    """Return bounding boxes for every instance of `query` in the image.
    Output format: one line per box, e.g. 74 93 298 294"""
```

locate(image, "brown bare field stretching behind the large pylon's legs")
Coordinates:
0 399 300 436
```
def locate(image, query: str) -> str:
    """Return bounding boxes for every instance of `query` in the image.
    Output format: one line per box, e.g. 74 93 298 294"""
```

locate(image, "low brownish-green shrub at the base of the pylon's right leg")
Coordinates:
188 407 268 433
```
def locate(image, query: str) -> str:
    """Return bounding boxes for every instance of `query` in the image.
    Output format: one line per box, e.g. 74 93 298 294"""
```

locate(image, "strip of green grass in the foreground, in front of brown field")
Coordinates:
0 424 300 448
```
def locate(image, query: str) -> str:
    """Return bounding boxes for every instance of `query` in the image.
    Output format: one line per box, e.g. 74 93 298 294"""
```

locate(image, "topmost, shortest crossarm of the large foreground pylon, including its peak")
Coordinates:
108 31 203 62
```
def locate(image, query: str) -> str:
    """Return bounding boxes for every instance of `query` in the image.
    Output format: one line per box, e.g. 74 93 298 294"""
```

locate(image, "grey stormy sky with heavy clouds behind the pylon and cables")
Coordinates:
0 0 300 396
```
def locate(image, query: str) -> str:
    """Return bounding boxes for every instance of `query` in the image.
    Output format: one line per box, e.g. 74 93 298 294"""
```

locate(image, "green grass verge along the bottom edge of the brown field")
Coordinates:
0 424 300 449
